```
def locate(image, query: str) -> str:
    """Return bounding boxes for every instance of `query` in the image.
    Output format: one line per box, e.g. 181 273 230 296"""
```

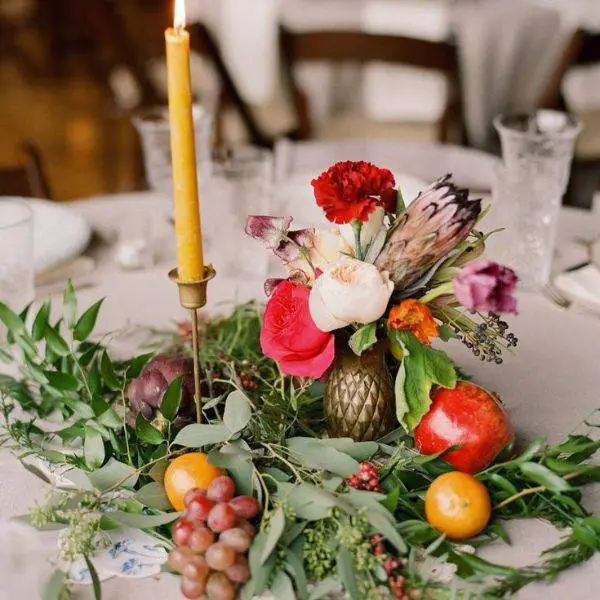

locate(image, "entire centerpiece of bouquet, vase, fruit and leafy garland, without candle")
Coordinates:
0 163 600 600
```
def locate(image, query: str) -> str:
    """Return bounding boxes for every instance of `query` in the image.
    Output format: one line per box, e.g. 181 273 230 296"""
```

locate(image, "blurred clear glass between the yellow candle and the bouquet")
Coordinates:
200 146 273 279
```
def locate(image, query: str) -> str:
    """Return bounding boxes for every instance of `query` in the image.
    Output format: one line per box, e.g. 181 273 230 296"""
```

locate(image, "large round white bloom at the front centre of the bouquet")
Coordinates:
309 257 394 331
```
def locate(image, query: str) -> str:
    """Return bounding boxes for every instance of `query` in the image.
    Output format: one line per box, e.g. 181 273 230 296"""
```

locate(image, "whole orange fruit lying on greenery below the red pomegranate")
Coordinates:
425 471 492 540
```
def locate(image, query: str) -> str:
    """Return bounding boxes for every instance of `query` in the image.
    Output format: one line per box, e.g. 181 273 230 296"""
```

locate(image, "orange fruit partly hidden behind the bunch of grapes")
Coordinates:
164 452 224 510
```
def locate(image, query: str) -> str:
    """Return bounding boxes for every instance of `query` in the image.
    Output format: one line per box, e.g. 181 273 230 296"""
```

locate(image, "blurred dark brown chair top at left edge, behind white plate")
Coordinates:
0 144 52 200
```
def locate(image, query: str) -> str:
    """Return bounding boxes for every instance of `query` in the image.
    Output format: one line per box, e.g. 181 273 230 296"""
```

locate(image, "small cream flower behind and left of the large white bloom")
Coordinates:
285 229 354 283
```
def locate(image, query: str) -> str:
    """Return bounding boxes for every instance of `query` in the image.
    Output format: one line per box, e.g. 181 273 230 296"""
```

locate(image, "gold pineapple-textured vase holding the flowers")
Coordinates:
324 344 394 441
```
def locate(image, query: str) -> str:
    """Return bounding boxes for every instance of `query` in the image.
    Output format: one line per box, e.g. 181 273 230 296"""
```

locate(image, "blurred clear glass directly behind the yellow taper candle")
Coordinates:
133 104 213 196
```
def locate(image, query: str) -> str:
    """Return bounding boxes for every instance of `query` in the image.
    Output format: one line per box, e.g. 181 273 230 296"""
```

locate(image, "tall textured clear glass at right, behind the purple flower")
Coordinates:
493 110 581 289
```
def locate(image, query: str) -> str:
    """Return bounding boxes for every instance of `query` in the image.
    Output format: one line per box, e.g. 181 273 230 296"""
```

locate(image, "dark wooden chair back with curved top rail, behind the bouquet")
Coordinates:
280 28 462 141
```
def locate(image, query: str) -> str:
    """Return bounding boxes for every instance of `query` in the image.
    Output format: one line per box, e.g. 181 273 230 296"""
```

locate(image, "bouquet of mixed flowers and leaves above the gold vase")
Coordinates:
246 162 517 438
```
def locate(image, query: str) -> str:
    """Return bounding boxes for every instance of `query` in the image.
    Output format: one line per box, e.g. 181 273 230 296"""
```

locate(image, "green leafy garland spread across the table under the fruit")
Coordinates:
0 285 600 600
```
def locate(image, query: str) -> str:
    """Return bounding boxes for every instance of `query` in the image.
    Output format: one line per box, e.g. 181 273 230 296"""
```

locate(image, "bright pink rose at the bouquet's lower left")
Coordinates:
260 280 335 379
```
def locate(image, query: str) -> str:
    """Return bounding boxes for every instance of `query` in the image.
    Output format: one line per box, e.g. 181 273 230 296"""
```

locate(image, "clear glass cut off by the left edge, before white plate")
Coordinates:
0 198 35 324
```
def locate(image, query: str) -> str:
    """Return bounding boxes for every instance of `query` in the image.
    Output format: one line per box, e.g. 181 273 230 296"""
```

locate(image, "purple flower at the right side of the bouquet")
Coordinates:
454 259 518 314
